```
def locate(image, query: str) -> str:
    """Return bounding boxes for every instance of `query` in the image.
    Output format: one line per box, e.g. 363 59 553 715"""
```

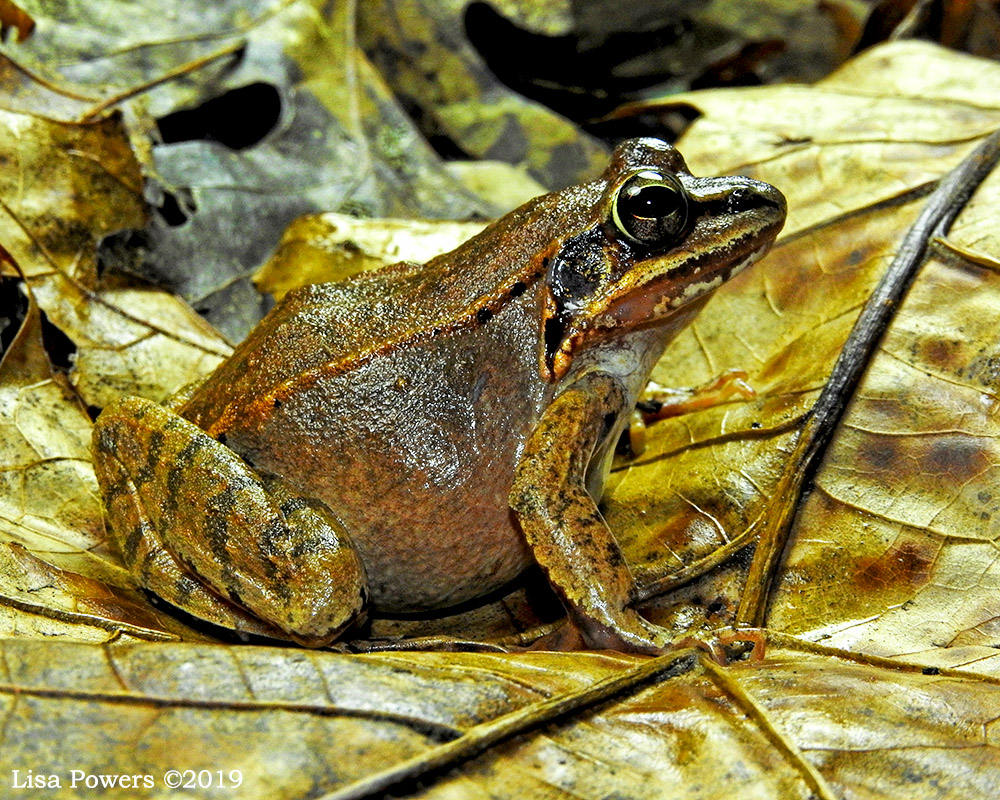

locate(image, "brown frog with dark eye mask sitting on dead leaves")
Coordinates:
92 138 786 654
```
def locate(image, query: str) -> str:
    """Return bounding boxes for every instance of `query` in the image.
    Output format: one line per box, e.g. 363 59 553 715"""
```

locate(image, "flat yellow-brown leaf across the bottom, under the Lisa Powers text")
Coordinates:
0 641 1000 800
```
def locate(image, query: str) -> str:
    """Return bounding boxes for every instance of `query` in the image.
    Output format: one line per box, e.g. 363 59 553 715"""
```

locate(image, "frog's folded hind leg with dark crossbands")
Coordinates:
93 397 367 645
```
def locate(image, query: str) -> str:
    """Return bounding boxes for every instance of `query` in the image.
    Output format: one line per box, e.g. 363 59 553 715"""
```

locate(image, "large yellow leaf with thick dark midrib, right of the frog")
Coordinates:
607 43 1000 655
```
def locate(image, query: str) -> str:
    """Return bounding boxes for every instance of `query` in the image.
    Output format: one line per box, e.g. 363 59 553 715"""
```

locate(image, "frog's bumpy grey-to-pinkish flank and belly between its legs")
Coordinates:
230 354 540 613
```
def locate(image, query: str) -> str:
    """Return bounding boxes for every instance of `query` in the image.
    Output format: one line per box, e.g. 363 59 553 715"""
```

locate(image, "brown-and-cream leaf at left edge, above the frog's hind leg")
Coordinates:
0 101 230 407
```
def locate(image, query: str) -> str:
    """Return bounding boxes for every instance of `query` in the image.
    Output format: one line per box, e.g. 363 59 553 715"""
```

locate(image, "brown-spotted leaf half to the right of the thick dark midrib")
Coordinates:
776 152 1000 654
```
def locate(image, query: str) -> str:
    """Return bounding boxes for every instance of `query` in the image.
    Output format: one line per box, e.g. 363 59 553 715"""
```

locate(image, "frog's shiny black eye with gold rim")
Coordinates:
611 169 688 247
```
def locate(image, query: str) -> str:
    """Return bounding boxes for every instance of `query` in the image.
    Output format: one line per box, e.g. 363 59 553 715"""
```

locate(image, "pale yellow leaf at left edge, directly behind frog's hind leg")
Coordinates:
0 302 209 641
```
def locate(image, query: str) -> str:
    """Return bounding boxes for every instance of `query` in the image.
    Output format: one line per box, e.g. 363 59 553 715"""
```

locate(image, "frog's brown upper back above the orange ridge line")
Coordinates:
182 186 592 434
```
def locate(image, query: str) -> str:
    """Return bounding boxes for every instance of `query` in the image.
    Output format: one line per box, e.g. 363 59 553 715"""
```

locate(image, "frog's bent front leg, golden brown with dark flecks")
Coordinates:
510 375 670 652
